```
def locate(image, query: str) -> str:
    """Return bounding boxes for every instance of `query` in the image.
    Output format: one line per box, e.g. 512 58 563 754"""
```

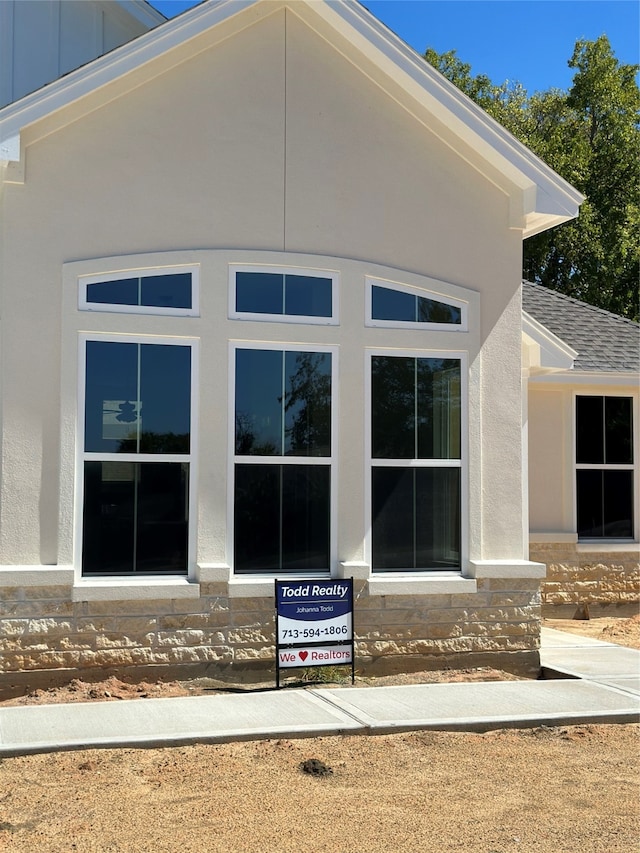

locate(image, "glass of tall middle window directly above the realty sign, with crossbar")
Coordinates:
234 347 334 573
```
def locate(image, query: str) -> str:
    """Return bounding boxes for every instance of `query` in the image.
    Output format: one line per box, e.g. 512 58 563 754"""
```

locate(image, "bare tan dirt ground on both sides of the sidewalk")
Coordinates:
0 617 640 853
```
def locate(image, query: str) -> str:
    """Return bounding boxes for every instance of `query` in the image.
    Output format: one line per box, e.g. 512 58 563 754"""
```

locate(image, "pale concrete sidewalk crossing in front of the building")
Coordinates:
0 628 640 756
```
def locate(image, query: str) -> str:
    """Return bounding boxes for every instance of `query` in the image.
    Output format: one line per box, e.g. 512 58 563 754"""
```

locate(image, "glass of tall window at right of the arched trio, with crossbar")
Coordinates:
371 355 462 572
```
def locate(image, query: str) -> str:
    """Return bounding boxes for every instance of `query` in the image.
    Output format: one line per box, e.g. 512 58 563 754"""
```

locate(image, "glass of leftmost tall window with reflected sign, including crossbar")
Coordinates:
82 340 192 576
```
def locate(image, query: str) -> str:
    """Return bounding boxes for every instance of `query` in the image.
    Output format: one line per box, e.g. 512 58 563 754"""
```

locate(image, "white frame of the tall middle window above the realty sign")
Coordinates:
227 340 339 580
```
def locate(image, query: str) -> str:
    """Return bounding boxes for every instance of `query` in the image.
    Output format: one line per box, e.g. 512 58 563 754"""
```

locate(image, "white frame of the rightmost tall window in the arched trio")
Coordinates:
364 350 469 579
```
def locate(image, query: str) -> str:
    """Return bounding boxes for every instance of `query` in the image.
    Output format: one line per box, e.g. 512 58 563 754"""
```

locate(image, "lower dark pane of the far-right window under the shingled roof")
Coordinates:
576 469 633 539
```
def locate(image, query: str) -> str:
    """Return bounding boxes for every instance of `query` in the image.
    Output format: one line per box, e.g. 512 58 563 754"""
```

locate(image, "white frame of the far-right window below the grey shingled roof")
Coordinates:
571 389 640 545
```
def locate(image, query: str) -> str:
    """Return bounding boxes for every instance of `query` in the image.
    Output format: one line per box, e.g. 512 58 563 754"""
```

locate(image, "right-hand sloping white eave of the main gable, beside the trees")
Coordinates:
293 0 584 237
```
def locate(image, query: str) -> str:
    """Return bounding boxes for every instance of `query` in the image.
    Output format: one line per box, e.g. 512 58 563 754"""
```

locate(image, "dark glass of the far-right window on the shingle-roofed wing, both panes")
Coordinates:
576 396 634 539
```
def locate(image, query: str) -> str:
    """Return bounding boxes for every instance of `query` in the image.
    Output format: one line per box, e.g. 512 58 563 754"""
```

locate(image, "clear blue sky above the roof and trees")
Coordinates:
151 0 640 92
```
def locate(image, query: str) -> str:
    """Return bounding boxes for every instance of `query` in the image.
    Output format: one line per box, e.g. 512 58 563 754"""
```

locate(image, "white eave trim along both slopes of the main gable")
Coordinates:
0 0 583 237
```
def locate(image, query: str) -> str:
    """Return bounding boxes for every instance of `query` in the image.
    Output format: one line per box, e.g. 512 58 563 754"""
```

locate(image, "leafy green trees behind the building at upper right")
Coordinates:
425 36 640 320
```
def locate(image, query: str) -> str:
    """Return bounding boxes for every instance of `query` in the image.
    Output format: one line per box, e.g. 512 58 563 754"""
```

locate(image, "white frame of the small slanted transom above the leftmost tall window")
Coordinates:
78 264 200 317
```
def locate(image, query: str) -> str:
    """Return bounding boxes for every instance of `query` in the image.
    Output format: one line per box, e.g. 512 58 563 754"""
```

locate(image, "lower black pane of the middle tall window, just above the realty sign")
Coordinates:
234 465 330 572
